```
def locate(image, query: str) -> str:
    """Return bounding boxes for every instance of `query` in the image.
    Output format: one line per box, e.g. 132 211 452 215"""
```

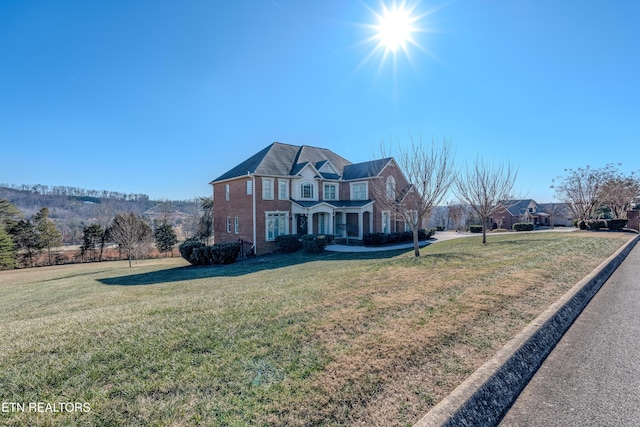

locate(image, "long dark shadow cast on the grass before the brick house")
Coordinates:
98 249 408 286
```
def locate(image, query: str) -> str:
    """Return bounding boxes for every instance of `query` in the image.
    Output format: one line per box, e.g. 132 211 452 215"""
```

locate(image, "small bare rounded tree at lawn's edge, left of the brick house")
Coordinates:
109 212 153 267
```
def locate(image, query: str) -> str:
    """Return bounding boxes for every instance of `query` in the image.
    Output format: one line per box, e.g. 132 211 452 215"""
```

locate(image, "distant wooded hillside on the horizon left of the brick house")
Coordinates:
0 184 205 244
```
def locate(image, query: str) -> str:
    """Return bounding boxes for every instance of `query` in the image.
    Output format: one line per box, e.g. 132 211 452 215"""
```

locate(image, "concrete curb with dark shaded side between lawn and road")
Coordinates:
414 236 640 427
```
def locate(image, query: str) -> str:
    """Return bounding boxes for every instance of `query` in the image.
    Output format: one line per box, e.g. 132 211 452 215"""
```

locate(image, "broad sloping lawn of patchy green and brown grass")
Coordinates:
0 232 632 426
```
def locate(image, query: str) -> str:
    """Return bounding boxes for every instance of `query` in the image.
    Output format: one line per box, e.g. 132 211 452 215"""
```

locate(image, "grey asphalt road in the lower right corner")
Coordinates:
500 244 640 427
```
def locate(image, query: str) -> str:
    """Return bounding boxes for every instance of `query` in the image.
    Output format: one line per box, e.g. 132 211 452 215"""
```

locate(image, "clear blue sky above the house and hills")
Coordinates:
0 0 640 202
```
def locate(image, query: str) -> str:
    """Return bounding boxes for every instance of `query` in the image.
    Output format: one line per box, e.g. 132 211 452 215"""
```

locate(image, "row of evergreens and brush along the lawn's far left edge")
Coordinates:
0 197 213 269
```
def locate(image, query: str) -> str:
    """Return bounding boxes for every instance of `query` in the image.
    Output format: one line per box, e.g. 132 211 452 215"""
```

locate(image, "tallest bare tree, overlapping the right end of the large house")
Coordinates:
372 136 455 257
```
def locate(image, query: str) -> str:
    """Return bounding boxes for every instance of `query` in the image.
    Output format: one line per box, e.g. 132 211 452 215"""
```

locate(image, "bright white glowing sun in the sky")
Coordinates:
375 4 417 54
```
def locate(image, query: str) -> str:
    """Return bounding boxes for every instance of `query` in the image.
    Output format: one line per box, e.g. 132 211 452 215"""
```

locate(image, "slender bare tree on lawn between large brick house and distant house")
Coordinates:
456 158 518 243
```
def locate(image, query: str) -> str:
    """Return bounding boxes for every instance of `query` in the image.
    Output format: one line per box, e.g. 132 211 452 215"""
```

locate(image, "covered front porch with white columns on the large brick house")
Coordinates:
291 200 373 240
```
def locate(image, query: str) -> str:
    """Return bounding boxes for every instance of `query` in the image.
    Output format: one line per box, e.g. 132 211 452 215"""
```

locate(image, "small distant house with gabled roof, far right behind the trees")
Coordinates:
490 199 571 230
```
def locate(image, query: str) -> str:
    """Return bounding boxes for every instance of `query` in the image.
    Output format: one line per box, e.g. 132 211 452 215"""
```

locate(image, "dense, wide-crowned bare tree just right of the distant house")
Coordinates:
551 166 606 220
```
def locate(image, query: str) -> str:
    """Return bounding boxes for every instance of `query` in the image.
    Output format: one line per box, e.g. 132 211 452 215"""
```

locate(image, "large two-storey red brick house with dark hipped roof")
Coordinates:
210 142 408 254
